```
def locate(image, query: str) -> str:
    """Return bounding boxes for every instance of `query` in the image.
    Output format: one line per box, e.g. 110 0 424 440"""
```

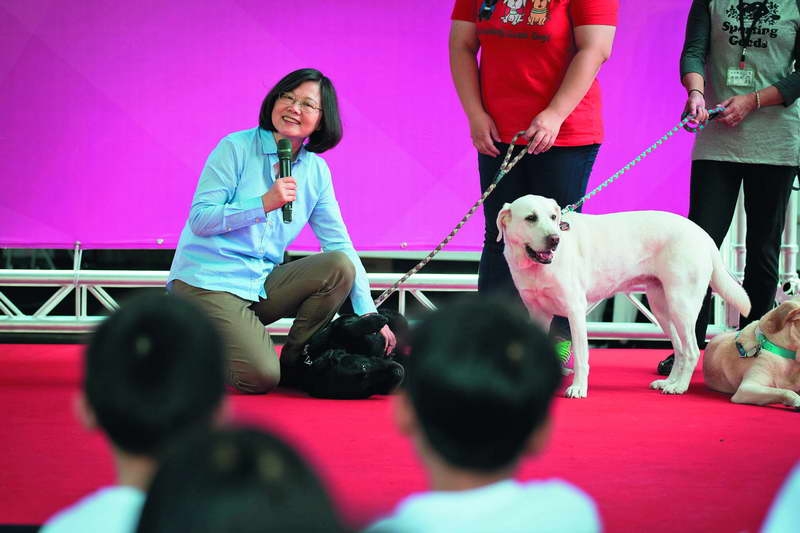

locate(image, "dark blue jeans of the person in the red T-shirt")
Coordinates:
478 143 600 338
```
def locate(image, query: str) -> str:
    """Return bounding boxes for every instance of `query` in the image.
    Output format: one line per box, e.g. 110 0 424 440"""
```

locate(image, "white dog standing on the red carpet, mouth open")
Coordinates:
497 195 750 398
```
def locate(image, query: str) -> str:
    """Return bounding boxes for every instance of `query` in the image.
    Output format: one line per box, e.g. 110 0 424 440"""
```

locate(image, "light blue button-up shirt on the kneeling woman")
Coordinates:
167 128 375 315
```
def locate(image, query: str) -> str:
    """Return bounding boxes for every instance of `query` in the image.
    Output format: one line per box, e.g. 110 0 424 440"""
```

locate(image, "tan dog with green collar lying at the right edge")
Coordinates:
703 300 800 411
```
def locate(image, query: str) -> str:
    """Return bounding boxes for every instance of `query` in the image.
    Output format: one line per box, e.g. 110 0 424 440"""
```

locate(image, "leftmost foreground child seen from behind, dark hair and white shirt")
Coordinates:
42 295 225 533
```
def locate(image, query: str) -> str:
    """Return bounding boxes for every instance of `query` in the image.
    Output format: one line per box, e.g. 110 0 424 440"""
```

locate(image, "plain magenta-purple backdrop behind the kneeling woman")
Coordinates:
0 0 691 251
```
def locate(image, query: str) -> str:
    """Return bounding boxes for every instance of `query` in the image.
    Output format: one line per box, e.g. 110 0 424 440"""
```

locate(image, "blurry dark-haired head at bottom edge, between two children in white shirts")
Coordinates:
137 428 344 533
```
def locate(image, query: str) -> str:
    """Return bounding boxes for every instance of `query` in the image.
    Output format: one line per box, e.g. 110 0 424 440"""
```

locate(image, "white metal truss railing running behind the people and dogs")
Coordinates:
0 192 800 340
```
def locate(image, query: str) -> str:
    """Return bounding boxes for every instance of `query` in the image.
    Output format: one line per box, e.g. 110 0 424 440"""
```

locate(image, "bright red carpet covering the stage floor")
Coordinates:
0 345 800 533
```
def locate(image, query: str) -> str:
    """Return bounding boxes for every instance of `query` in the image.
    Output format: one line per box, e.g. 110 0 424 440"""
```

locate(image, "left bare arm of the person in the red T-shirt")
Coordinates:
449 20 500 156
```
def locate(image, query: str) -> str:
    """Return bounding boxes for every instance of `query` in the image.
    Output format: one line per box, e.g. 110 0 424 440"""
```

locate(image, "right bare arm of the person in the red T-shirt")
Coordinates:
525 24 616 154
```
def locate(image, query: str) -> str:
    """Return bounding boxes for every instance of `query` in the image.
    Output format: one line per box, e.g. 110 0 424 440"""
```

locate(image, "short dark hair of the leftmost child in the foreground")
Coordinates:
83 293 225 455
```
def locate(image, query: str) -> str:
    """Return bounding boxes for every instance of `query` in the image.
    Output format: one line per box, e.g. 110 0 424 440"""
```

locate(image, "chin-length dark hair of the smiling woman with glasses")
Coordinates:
258 68 342 154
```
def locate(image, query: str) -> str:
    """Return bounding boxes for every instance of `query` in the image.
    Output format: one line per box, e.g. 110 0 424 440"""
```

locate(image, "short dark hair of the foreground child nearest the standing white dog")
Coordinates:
404 297 561 472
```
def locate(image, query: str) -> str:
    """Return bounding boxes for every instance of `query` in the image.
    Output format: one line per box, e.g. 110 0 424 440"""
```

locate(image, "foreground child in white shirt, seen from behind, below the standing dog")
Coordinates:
367 299 601 533
